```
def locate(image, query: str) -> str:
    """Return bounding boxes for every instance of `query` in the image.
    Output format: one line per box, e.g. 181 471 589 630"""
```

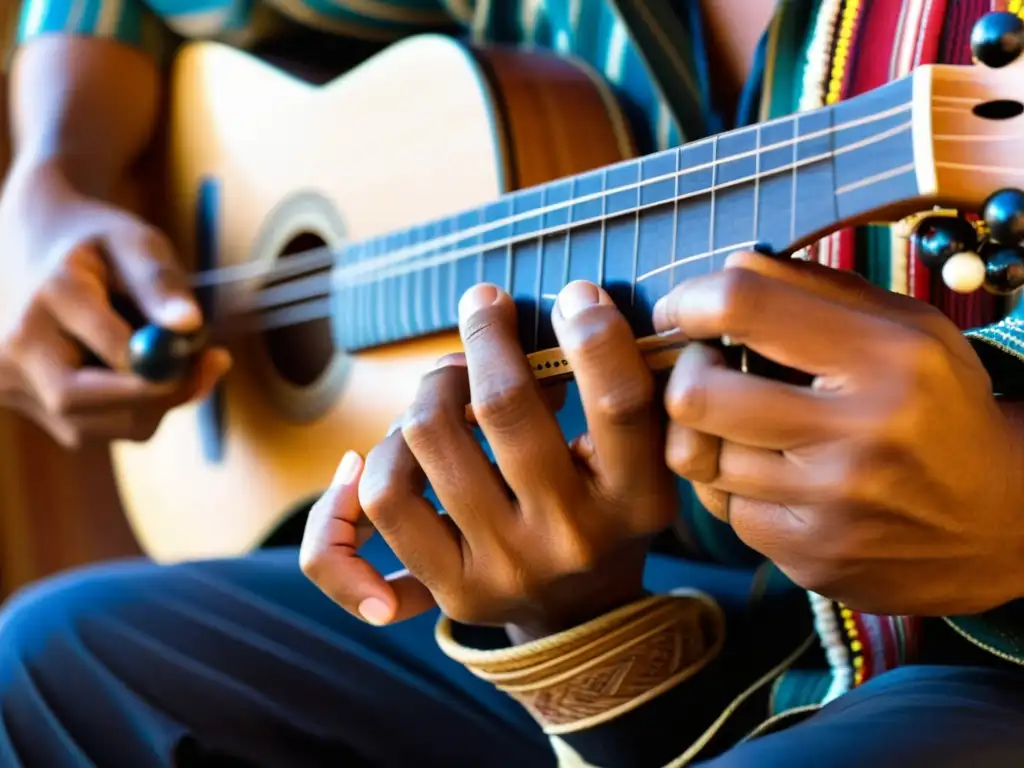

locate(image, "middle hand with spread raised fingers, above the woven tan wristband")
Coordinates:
302 284 677 640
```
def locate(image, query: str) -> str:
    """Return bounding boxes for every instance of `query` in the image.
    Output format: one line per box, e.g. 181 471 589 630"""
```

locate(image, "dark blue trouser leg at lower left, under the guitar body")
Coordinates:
0 547 554 768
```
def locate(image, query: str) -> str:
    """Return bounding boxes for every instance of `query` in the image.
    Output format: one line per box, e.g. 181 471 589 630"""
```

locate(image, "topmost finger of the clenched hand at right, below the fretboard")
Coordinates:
654 267 893 376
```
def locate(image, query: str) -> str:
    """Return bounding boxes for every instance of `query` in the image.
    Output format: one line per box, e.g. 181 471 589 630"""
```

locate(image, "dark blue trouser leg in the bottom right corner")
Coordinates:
705 667 1024 768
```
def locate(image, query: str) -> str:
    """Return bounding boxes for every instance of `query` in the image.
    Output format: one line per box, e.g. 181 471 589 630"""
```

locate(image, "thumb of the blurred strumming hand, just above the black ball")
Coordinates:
102 222 203 333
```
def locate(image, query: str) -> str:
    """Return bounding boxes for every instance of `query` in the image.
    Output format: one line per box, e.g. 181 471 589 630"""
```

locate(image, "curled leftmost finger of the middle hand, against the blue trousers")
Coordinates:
299 451 434 626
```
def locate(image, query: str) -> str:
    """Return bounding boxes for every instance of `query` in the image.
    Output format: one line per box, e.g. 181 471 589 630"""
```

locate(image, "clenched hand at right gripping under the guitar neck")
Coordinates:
654 253 1024 615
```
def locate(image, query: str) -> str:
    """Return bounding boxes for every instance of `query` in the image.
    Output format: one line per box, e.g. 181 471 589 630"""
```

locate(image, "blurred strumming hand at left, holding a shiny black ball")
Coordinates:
0 159 230 447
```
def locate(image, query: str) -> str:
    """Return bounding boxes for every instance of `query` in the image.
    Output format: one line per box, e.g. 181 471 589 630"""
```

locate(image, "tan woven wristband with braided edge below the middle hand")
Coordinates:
434 592 725 735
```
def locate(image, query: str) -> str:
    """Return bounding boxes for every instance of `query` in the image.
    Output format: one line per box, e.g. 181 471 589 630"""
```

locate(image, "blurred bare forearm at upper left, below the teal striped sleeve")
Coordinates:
9 35 161 198
